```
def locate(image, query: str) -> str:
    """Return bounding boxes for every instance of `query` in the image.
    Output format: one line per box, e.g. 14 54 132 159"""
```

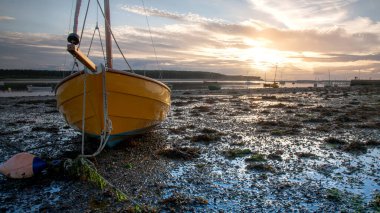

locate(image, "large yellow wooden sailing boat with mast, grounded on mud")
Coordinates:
55 0 171 147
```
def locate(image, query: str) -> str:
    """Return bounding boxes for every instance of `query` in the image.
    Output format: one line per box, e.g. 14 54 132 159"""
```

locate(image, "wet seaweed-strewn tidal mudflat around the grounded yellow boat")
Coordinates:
0 87 380 212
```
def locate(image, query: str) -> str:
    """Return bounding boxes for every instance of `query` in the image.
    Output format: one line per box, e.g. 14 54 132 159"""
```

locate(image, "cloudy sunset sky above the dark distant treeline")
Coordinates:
0 0 380 80
